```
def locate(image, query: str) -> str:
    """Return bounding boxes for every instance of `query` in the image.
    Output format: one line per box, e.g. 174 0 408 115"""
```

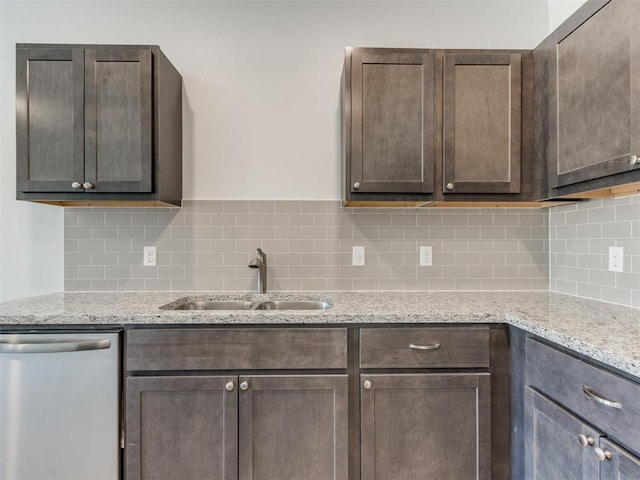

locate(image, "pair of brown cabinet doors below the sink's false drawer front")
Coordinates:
126 375 348 480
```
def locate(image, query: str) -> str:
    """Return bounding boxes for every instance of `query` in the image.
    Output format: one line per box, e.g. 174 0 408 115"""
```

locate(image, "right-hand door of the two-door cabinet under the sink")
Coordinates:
239 375 348 480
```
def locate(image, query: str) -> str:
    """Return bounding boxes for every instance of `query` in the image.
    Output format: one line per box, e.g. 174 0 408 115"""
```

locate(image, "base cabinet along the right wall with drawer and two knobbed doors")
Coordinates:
515 338 640 480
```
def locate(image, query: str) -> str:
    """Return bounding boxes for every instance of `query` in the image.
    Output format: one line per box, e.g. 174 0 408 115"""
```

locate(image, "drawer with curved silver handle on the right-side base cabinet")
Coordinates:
526 338 640 451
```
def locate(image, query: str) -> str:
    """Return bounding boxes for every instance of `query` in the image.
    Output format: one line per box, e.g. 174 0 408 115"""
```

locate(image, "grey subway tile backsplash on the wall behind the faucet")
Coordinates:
65 200 552 291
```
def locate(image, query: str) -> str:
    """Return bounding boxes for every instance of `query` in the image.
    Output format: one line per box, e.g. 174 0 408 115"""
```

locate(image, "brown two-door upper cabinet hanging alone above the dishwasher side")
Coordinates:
16 44 182 205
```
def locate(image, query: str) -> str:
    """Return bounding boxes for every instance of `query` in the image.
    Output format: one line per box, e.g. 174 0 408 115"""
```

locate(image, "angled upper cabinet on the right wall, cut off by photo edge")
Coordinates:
534 0 640 196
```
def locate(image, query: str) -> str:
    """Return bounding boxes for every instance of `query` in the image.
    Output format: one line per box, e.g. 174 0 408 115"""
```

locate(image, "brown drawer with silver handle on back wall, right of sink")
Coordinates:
360 327 489 368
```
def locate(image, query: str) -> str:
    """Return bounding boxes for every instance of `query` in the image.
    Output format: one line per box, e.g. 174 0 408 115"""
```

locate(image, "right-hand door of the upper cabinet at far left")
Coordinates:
85 49 153 193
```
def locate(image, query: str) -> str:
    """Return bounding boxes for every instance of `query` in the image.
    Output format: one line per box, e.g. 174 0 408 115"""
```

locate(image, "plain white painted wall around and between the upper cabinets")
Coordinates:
0 0 557 301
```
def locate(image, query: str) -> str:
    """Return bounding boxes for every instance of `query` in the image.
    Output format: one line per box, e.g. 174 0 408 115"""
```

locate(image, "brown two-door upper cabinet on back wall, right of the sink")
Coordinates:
342 48 540 206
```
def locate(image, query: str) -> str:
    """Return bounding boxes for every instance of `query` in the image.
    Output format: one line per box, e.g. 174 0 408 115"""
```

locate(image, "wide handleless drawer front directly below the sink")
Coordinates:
125 328 347 371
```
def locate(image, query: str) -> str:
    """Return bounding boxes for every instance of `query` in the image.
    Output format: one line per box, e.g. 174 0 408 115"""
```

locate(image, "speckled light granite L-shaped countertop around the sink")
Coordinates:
0 292 640 378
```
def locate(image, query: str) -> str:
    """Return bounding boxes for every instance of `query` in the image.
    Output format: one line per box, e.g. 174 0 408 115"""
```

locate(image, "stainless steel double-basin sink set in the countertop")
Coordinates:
160 299 333 310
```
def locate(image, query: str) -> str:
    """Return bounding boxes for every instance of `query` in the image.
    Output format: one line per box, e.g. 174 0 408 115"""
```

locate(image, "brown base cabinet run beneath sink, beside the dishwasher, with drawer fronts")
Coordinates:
124 325 510 480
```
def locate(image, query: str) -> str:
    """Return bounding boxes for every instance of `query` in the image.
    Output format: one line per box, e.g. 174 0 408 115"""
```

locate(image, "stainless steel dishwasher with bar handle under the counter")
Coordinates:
0 332 120 480
